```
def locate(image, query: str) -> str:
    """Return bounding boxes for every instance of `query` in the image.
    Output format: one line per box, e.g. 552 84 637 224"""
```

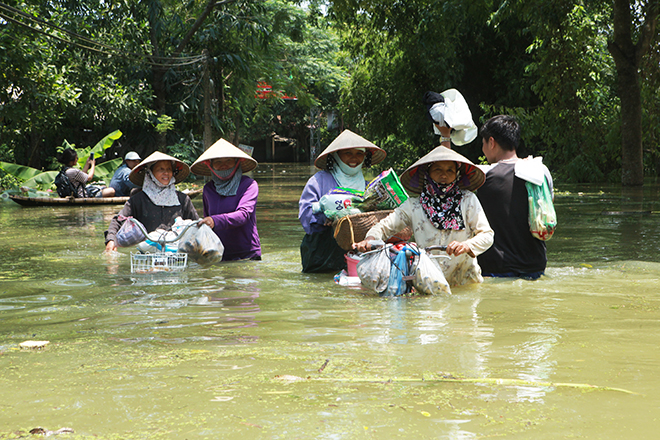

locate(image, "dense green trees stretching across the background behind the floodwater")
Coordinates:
0 0 660 185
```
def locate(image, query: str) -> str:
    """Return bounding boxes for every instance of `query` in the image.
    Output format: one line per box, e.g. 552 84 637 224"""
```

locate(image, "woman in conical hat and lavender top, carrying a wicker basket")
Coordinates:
298 130 386 273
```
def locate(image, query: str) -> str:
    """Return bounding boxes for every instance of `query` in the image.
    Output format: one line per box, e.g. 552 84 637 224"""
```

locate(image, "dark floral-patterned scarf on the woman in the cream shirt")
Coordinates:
419 165 465 230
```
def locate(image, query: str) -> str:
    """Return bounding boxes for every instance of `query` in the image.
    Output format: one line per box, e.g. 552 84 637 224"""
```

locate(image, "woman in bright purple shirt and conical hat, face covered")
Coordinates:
190 139 261 261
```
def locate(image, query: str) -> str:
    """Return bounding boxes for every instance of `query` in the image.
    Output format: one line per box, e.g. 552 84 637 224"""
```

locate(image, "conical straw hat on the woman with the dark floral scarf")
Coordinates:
400 146 486 195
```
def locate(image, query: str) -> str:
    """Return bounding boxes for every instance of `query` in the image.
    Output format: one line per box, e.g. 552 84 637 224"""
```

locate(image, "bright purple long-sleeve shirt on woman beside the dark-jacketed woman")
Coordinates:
202 176 261 261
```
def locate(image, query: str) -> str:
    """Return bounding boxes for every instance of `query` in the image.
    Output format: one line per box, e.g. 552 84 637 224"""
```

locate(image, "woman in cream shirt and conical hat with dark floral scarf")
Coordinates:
353 146 494 286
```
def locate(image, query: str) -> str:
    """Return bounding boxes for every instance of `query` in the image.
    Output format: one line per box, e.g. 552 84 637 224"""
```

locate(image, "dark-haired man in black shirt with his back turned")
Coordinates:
477 115 552 280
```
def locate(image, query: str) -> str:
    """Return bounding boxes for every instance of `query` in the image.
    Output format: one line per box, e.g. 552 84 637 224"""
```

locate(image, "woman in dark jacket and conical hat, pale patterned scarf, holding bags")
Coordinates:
105 151 199 252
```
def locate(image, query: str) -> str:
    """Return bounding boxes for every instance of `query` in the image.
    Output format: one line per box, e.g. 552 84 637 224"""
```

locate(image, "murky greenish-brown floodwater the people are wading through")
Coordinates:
0 164 660 440
